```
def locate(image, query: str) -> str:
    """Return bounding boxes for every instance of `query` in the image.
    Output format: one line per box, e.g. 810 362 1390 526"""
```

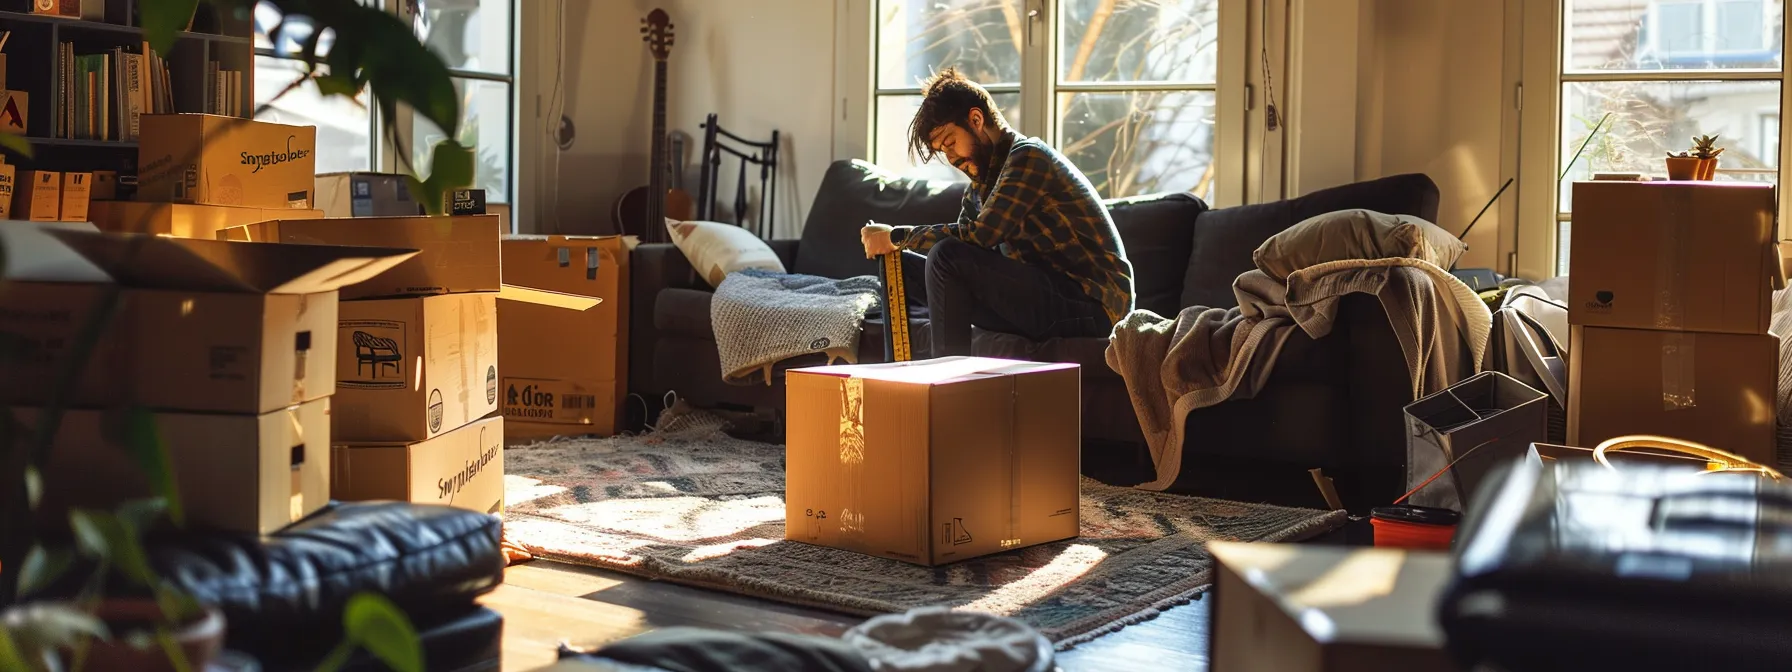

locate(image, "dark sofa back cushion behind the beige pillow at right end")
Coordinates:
1181 174 1437 308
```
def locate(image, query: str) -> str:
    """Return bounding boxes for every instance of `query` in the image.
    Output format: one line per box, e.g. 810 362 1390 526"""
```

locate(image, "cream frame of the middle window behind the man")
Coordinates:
833 0 1247 208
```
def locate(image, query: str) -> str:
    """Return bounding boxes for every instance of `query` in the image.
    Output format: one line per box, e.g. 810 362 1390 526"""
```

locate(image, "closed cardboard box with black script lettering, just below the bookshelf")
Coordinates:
136 115 317 210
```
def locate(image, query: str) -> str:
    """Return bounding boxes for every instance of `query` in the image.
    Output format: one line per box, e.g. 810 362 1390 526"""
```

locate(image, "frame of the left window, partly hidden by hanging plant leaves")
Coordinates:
249 0 523 205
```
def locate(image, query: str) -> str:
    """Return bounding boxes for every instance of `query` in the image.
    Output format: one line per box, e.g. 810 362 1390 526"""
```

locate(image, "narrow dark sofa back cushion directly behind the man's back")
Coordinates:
1107 194 1208 317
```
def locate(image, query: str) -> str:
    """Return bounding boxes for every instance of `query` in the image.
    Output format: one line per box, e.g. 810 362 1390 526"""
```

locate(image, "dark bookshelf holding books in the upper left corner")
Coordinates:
0 0 254 174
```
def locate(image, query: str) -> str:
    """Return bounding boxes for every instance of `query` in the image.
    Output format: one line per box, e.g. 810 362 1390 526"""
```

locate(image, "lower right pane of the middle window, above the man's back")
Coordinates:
1059 91 1215 201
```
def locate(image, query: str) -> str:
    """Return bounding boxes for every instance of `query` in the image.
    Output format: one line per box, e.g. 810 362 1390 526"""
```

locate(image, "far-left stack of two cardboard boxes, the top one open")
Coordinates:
0 224 414 534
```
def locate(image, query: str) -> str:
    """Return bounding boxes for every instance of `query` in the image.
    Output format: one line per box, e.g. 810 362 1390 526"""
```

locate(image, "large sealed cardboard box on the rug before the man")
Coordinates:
785 357 1082 564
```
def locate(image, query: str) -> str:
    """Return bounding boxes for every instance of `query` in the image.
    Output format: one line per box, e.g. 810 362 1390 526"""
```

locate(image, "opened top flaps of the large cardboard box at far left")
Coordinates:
50 231 418 294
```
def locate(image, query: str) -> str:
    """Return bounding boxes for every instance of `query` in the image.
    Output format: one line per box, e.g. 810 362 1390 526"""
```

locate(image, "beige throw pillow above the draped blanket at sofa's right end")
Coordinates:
1251 210 1468 280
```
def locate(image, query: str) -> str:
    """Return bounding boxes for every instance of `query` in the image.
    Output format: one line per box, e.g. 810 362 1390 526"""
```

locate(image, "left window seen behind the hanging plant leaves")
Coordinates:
254 0 516 202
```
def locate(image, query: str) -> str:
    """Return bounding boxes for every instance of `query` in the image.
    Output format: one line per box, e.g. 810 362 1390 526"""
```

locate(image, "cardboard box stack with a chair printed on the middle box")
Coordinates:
220 215 530 513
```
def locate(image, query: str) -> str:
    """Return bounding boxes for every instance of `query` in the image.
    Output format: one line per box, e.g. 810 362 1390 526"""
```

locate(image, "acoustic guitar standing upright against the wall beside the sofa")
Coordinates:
613 9 695 242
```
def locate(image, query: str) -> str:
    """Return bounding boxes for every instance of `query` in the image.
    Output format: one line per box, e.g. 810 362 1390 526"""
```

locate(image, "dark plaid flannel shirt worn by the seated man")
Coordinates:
898 131 1133 323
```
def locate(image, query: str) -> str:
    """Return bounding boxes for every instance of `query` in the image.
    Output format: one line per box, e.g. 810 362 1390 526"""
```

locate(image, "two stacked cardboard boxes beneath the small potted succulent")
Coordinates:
1568 181 1779 464
